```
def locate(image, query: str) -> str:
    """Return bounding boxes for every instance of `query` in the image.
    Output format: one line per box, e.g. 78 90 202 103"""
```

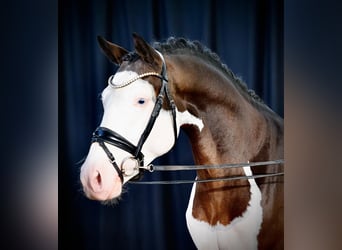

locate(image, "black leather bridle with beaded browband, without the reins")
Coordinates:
92 53 177 184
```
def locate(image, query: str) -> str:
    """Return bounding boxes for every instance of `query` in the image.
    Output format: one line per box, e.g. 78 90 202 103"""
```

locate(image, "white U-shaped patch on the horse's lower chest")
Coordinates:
186 167 263 250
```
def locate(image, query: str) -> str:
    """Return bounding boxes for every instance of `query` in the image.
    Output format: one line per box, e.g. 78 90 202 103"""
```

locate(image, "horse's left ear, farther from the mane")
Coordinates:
97 36 128 65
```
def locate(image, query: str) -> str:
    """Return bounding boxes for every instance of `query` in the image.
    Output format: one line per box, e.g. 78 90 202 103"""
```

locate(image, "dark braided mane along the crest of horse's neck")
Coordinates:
152 37 264 104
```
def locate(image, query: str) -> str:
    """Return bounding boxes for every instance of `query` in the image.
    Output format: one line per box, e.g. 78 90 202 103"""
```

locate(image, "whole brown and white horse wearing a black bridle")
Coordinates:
80 33 284 249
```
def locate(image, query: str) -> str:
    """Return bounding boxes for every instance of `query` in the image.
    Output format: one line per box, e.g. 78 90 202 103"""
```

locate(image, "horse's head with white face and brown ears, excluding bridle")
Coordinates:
80 34 203 200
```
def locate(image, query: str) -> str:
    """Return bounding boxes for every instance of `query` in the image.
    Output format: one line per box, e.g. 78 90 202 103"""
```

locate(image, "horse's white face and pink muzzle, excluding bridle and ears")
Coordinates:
80 71 178 200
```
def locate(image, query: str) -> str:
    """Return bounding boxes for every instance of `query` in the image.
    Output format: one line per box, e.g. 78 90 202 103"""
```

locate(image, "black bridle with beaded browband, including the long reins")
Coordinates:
91 51 284 184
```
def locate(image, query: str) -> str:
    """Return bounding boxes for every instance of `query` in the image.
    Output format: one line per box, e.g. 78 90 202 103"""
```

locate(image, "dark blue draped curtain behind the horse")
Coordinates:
59 0 283 250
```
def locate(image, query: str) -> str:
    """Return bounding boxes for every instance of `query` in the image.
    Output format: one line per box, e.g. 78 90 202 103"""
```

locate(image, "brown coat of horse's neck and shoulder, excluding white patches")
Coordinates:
157 46 284 249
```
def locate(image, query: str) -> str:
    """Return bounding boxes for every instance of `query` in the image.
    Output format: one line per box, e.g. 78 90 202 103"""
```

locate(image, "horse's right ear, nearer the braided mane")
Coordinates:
133 33 161 64
